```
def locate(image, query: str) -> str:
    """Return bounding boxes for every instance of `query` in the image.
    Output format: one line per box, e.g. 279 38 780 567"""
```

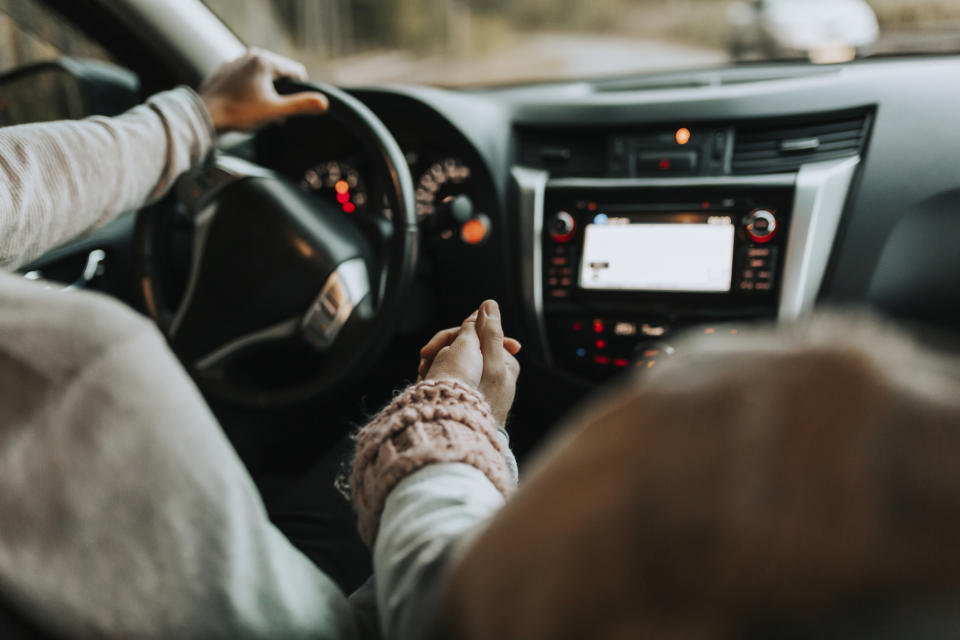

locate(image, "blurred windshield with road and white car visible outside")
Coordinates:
206 0 960 86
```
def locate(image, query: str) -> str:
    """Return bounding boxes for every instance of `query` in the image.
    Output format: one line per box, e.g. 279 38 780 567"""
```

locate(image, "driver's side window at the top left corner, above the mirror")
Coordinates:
0 0 111 73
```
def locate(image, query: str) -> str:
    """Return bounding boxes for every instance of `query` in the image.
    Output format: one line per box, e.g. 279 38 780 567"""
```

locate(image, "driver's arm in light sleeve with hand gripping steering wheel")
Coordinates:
0 50 327 268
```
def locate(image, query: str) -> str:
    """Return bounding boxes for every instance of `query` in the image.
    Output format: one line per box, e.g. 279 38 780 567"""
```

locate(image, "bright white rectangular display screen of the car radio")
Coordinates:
580 216 735 293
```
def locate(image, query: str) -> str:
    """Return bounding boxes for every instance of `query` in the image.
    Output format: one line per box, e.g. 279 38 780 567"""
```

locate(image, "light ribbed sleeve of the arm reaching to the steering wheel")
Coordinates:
0 87 214 268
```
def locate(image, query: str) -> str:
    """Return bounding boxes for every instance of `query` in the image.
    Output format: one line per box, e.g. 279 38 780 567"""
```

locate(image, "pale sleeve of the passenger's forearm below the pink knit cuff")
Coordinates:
373 464 512 640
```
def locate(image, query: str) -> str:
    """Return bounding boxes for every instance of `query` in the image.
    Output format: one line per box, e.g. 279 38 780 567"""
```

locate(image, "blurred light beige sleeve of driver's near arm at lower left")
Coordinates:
0 282 356 640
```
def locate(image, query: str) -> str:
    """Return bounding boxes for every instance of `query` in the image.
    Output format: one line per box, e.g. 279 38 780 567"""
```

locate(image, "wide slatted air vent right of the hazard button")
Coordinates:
733 114 867 173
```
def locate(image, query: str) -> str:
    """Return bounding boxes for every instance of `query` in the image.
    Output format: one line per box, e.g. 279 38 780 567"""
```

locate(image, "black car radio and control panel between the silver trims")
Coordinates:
539 186 793 377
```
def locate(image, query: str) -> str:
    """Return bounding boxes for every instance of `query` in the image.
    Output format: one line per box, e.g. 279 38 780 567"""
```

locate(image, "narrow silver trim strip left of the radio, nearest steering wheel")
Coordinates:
510 166 553 364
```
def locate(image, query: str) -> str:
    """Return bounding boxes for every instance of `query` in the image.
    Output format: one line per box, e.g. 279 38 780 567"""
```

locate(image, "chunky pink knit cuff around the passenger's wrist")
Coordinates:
350 380 513 545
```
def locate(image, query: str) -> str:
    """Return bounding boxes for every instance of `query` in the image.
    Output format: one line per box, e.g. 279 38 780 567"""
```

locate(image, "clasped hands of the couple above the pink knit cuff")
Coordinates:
418 300 520 425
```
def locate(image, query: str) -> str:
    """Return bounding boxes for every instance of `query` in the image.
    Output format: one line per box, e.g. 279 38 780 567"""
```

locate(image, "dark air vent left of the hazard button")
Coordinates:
519 129 607 176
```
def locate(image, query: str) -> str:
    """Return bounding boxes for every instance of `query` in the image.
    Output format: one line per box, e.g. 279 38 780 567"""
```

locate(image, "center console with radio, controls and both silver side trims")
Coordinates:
513 158 859 379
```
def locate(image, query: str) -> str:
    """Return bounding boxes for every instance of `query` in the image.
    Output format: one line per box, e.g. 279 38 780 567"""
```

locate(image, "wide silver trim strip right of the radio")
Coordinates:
778 156 860 320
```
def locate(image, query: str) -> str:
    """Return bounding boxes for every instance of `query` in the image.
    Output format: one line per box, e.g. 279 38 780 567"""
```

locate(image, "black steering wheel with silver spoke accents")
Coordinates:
134 81 419 406
